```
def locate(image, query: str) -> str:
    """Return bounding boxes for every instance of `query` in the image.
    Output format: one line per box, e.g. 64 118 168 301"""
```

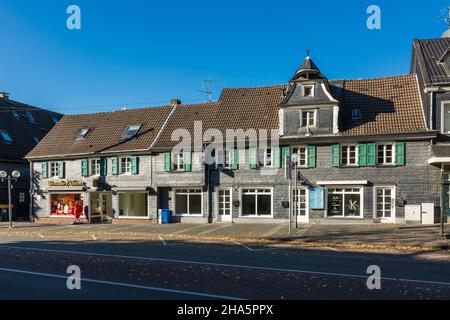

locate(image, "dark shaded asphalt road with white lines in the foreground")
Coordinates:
0 236 450 300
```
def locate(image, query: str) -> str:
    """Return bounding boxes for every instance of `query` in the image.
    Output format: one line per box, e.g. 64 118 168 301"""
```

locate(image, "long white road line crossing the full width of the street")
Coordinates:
0 245 450 286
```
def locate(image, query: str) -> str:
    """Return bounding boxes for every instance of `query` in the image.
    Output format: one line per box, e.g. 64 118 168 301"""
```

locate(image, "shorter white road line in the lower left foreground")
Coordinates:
0 268 245 300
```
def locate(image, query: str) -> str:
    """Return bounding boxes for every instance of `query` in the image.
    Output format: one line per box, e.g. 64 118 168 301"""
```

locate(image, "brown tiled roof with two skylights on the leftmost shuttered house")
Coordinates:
27 106 173 158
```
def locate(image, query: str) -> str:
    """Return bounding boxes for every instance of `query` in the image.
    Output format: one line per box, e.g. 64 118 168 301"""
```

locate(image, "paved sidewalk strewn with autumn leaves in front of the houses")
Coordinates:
0 223 450 253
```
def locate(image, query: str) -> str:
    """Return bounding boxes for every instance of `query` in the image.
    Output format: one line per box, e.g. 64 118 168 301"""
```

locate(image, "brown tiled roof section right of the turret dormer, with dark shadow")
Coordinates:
331 75 427 136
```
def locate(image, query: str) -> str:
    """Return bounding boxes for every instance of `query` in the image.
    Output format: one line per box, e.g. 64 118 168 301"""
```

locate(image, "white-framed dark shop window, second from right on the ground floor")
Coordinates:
242 189 272 216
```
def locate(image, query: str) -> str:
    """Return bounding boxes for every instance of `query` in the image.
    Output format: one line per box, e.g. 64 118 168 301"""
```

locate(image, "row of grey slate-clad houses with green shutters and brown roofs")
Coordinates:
27 39 450 223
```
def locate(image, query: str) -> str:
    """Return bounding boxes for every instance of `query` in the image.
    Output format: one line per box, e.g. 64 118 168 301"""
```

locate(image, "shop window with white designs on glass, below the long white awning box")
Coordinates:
328 188 362 217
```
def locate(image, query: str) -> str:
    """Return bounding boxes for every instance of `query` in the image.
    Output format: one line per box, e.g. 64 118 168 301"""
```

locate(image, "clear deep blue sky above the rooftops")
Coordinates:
0 0 449 114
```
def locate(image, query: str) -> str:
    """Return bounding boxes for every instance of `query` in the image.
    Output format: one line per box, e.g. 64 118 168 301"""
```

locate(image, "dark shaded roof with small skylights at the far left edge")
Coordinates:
0 98 62 162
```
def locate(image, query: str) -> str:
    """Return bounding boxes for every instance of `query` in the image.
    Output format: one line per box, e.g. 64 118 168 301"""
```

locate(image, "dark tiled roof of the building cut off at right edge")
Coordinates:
411 38 450 85
